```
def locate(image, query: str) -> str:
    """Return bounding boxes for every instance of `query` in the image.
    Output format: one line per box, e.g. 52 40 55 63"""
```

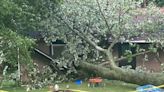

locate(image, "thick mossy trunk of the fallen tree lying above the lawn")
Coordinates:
79 62 164 85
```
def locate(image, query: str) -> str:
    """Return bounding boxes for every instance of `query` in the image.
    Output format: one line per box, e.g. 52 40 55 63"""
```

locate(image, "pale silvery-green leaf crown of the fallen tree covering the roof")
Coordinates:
38 0 164 71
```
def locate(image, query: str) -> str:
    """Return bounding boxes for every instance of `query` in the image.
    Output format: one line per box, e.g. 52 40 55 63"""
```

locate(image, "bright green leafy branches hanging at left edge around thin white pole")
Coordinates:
0 28 34 69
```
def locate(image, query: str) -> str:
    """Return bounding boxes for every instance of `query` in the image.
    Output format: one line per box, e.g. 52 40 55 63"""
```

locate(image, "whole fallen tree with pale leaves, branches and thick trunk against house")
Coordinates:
41 0 164 85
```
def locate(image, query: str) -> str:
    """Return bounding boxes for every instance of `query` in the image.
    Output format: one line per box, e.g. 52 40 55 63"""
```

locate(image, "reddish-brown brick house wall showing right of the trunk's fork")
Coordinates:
113 43 164 72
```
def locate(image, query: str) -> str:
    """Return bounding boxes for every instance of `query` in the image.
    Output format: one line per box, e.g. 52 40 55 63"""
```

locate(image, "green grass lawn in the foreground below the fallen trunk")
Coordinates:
0 81 137 92
